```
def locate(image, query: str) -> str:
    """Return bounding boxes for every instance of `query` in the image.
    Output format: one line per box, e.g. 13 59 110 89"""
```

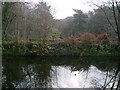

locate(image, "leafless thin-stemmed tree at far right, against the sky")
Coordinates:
89 0 120 41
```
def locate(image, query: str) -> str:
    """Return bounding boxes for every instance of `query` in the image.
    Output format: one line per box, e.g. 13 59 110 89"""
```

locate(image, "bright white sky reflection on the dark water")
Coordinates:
51 66 105 88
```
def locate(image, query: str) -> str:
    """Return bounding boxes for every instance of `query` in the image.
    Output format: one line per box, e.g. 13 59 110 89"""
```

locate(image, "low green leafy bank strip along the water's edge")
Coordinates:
2 42 120 56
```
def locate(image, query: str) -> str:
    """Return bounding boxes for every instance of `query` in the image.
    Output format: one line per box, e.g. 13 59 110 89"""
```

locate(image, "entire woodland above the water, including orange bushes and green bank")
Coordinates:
0 1 120 56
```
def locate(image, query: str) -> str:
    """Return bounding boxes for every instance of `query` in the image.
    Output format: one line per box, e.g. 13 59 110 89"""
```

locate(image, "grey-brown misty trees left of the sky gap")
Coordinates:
2 2 53 42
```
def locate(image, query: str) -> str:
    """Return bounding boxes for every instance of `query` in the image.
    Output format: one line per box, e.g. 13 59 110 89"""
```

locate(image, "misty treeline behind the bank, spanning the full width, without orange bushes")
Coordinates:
2 1 120 42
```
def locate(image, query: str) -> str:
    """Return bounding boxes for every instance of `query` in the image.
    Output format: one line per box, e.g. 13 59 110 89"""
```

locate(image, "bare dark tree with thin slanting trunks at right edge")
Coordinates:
89 0 120 41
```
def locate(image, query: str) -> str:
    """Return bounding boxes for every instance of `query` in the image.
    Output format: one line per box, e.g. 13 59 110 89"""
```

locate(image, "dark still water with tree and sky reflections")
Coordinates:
2 56 120 88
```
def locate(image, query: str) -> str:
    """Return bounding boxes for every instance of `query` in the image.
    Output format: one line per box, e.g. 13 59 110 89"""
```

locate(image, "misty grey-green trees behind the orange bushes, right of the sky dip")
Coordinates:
55 2 120 40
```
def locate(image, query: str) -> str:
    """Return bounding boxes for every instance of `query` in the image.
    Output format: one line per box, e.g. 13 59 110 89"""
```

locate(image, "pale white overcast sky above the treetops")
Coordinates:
31 0 108 19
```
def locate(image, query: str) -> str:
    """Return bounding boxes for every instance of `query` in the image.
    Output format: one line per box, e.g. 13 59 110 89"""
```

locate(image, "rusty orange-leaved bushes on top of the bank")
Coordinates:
67 32 110 44
